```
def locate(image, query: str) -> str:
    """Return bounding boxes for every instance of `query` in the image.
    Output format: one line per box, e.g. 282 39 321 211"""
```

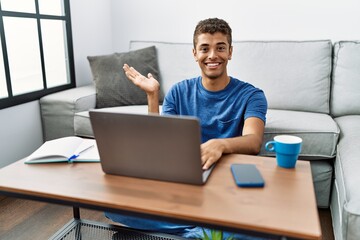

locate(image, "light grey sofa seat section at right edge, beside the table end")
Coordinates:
331 115 360 239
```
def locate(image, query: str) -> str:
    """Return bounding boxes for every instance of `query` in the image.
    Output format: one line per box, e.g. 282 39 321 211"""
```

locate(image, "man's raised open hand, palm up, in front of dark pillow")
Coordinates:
123 64 160 95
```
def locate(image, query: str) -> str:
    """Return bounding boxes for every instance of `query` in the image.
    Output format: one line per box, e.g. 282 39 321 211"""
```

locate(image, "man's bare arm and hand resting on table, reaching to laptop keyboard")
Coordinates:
201 117 265 169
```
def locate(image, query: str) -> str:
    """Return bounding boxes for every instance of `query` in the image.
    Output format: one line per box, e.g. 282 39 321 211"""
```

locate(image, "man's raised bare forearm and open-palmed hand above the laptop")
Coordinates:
123 64 160 114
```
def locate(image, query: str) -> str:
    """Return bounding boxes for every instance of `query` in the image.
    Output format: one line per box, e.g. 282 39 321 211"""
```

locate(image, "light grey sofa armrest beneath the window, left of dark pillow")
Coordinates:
40 84 96 141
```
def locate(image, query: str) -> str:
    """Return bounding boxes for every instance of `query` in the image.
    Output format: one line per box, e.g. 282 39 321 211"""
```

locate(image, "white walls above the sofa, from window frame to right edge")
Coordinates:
71 0 360 86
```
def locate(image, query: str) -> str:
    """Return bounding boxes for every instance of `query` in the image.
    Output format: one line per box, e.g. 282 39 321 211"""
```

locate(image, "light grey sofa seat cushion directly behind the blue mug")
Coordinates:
260 109 340 159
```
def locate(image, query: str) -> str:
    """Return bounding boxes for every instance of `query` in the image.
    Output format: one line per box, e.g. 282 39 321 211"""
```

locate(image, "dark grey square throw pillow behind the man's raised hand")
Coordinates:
88 46 160 108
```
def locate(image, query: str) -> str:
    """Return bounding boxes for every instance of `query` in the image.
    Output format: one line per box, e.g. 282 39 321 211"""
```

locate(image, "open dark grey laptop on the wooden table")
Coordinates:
90 111 214 185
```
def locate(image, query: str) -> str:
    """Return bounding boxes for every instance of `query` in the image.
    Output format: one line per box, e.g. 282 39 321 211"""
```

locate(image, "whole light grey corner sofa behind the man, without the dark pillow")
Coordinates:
40 40 360 239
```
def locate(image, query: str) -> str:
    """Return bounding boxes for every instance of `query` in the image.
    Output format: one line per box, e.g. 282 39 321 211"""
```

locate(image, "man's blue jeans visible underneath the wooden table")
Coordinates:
105 212 270 240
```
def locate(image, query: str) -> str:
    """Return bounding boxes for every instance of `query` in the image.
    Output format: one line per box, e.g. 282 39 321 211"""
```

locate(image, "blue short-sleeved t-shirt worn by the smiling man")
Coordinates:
162 77 267 142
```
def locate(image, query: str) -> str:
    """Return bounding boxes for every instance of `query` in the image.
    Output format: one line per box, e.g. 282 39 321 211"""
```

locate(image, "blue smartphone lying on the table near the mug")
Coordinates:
231 163 265 187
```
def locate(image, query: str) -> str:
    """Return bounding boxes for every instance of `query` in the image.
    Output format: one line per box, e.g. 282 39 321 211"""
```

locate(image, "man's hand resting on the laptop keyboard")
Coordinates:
200 139 224 170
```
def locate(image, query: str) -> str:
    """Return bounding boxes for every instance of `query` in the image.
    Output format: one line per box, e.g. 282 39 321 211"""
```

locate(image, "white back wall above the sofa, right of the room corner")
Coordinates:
112 0 360 51
